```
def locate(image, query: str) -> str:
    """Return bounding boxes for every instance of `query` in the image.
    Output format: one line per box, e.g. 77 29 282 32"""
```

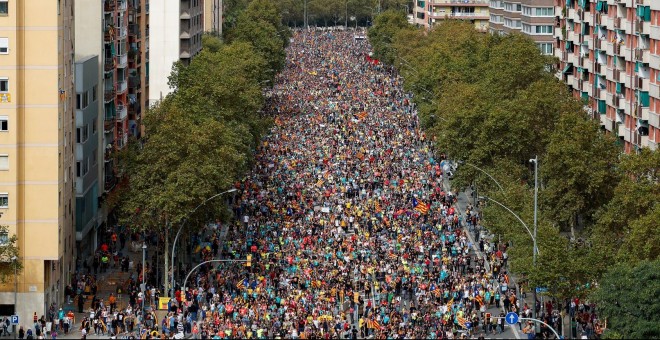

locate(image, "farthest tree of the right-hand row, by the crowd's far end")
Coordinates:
367 10 412 65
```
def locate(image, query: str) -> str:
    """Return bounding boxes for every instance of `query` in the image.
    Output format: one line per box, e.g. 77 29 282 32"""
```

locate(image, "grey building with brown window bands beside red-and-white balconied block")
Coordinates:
489 0 557 55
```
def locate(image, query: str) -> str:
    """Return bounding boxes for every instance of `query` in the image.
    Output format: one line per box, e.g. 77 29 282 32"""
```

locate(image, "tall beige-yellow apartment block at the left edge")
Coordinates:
0 0 76 323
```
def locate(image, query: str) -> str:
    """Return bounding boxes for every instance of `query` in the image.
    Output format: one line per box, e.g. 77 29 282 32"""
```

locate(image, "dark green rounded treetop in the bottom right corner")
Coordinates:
591 259 660 339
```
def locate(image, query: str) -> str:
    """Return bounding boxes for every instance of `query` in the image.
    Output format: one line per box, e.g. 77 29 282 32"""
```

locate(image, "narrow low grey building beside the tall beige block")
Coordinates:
75 57 102 259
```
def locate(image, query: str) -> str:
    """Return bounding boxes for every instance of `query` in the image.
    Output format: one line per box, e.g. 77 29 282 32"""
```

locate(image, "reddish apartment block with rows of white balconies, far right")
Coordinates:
555 0 660 152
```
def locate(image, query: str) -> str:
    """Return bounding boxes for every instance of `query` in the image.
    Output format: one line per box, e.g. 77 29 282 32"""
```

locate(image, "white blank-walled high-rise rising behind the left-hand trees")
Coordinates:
149 0 204 104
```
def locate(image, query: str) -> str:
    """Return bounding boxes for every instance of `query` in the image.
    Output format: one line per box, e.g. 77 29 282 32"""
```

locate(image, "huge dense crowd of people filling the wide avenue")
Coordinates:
20 30 597 339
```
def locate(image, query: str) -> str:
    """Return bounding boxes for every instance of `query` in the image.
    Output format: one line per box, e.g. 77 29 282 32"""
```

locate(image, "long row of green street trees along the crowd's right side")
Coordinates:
369 11 660 337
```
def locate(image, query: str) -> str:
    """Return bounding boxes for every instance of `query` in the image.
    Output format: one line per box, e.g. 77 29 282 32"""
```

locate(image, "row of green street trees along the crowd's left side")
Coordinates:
117 0 289 291
